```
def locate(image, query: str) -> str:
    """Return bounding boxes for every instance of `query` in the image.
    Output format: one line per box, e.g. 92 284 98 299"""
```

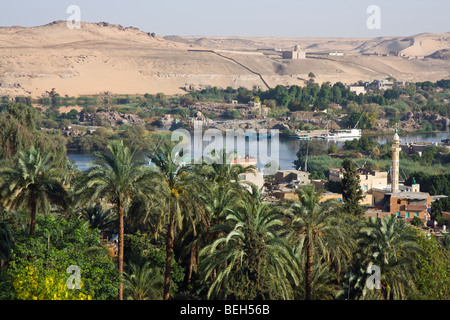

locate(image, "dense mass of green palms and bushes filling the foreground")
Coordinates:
0 141 449 300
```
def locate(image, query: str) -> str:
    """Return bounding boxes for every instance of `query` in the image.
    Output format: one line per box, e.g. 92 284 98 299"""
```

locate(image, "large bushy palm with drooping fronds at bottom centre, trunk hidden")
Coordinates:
200 185 298 299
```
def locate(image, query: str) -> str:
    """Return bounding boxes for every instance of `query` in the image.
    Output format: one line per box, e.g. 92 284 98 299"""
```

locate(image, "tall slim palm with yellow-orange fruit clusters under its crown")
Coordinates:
148 146 202 300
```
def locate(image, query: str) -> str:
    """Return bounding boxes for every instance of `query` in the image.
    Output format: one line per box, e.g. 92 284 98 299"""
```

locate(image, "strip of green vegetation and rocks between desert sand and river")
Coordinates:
0 77 450 151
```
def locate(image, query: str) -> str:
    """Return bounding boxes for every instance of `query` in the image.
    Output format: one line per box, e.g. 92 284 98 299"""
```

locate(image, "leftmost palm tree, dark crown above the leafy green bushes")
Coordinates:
0 147 70 236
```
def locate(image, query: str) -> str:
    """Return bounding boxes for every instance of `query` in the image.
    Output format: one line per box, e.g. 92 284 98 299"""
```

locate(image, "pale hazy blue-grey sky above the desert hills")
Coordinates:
0 0 450 37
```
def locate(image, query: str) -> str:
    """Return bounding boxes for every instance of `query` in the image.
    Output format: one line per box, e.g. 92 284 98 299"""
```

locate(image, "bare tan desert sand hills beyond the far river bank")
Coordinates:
0 21 450 97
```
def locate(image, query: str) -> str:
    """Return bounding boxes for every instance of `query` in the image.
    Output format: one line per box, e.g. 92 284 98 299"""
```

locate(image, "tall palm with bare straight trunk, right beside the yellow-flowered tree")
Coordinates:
76 140 153 300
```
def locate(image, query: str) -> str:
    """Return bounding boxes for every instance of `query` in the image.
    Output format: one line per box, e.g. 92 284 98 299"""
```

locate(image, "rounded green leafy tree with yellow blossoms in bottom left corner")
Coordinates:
7 215 118 300
